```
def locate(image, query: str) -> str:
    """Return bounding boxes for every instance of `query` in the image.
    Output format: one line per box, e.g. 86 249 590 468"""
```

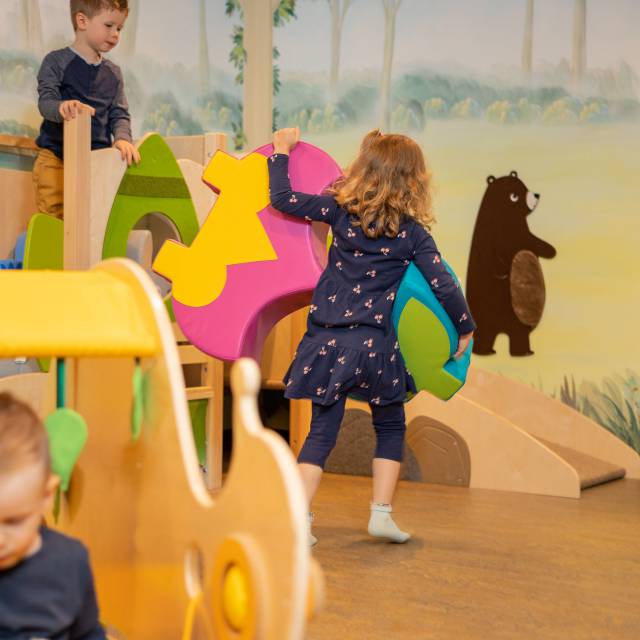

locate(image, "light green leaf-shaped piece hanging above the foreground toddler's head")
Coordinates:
44 409 89 492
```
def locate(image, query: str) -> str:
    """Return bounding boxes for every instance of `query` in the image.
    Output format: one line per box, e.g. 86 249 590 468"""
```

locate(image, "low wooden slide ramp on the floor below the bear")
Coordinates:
406 367 640 498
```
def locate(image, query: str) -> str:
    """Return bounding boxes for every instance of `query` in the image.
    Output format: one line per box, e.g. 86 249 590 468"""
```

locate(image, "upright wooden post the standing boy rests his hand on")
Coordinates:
64 109 91 269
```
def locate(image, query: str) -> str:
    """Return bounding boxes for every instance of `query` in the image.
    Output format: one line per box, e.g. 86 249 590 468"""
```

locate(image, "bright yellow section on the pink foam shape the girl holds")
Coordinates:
153 151 278 307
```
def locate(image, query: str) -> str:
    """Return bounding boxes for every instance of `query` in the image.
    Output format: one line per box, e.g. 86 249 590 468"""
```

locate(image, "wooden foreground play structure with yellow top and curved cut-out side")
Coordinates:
0 259 322 640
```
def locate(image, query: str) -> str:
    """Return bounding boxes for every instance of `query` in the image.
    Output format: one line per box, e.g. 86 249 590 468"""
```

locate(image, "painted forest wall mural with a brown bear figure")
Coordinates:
0 0 640 450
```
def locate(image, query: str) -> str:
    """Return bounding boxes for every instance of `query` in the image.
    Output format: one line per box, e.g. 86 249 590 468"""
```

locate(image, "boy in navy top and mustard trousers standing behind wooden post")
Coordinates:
33 0 140 218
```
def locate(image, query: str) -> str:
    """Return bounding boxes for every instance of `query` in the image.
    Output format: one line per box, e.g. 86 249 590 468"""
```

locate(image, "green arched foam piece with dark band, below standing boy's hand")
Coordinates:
102 134 199 258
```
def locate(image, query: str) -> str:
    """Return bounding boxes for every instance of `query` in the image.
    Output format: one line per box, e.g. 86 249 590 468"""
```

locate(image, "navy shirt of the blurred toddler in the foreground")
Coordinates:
0 527 106 640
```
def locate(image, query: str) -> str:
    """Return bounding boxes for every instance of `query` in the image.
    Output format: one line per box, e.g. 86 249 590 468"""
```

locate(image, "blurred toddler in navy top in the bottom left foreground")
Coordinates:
0 393 106 640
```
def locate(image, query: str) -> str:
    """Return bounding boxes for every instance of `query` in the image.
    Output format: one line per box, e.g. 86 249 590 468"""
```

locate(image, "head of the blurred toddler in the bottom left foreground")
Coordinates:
0 393 57 571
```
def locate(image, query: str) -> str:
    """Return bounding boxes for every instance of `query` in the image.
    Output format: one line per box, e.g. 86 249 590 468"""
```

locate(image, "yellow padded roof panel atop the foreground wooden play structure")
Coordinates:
0 270 160 357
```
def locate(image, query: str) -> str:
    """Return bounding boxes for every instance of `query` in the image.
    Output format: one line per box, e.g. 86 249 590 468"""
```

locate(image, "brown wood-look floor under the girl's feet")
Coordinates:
307 474 640 640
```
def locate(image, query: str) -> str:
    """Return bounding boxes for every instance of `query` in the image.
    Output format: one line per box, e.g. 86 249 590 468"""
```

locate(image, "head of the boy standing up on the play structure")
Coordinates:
70 0 129 53
